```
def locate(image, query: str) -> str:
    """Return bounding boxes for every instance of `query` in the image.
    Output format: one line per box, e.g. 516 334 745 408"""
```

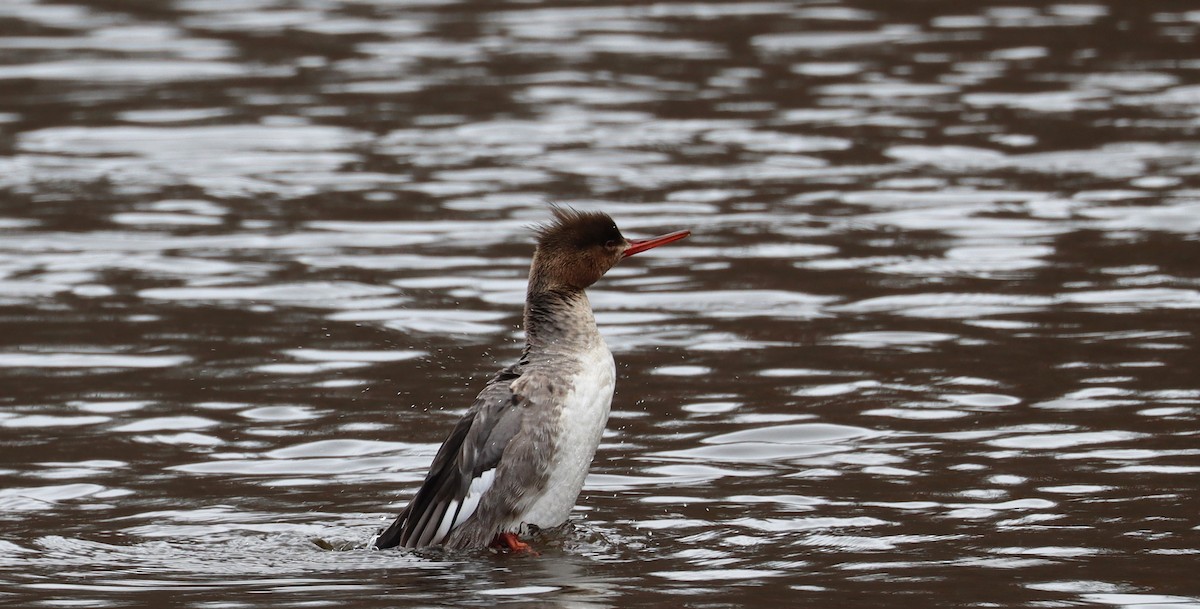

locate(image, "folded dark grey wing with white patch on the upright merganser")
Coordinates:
374 367 522 549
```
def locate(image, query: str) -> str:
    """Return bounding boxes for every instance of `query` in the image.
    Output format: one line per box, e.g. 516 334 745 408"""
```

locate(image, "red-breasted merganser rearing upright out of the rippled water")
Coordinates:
374 207 690 551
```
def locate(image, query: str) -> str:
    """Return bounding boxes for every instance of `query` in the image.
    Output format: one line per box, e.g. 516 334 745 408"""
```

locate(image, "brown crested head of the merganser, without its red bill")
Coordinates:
529 205 629 291
